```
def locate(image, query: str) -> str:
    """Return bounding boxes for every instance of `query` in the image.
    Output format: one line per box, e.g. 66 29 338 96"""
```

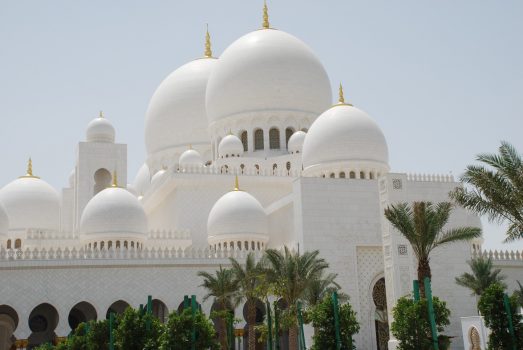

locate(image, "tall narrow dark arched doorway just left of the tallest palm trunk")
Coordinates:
372 277 389 350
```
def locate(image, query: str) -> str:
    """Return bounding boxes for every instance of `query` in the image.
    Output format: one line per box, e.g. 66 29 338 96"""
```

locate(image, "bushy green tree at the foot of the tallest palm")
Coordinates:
391 297 450 350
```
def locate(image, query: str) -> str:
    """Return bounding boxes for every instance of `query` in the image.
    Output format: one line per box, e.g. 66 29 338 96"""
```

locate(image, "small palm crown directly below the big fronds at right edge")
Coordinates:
456 256 506 296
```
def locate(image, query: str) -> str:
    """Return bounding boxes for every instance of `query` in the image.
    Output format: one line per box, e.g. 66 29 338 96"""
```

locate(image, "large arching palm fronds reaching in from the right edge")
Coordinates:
450 141 523 241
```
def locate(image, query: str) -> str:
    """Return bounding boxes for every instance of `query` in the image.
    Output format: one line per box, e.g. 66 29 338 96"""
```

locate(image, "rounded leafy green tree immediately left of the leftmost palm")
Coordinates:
156 309 220 350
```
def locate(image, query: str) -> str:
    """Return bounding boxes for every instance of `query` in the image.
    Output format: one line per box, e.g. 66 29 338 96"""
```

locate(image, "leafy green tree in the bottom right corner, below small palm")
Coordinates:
478 283 523 350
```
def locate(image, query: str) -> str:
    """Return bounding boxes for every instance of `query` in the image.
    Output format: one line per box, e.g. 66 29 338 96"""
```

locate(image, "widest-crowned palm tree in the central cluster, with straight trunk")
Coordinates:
265 247 329 350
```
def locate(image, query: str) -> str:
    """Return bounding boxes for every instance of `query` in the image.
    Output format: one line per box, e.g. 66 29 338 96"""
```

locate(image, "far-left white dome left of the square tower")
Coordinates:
0 176 60 230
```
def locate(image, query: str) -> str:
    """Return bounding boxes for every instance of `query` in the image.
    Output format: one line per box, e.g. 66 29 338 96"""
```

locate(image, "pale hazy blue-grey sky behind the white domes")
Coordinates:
0 0 523 249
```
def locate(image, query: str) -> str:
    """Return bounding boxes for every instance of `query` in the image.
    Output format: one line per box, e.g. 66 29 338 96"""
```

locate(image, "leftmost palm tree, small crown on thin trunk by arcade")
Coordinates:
198 265 238 349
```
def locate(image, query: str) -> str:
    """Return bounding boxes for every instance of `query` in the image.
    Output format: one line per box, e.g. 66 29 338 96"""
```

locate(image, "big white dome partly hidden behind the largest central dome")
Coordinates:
145 58 217 155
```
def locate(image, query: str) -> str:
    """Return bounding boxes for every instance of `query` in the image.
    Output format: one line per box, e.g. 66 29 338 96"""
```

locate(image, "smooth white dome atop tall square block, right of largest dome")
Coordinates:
302 104 389 171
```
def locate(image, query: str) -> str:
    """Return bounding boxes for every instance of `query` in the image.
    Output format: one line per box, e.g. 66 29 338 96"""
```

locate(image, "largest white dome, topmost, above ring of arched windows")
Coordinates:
206 29 332 126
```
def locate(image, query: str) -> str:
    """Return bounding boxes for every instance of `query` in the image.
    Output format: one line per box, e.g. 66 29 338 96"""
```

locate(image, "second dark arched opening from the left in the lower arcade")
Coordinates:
27 303 58 349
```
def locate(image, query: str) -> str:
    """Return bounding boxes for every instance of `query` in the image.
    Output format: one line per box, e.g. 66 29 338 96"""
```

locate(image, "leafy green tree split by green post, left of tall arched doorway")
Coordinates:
308 295 360 350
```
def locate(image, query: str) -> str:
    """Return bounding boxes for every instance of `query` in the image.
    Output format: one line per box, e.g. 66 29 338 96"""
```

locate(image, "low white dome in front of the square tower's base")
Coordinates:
80 187 147 240
